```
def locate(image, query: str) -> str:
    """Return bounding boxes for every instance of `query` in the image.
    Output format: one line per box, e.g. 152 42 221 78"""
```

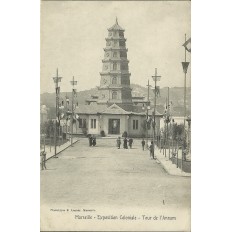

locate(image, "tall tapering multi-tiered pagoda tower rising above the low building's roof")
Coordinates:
98 18 132 111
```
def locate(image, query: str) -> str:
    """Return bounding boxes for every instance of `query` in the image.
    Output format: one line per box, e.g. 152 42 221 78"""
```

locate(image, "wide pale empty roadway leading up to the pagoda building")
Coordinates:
41 138 191 208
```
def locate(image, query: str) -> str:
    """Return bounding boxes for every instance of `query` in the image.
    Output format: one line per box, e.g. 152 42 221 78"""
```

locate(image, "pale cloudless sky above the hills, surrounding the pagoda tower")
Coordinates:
40 1 191 93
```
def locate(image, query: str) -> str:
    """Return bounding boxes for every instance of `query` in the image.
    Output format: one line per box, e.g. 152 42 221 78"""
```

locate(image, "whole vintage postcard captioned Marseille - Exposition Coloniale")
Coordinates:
40 0 191 231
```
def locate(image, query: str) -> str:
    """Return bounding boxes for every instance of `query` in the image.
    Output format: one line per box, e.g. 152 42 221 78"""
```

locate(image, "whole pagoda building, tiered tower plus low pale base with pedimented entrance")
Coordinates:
73 19 162 137
